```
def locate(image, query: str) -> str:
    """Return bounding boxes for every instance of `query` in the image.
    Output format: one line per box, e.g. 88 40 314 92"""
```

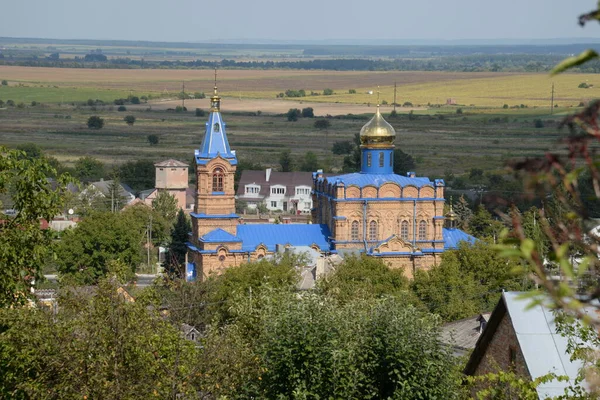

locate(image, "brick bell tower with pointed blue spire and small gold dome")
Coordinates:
191 70 239 239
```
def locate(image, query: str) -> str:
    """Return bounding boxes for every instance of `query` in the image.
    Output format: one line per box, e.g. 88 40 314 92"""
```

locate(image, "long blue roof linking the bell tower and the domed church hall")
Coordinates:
237 224 331 251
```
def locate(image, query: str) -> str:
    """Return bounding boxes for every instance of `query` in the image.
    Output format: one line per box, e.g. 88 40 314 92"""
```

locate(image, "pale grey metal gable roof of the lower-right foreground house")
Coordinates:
465 292 582 398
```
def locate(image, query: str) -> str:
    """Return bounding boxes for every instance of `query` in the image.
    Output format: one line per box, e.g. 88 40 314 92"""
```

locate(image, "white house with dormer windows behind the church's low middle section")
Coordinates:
237 168 313 215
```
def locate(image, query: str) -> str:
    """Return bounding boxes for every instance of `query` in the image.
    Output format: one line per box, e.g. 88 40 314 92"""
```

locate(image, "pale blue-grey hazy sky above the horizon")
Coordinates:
0 0 600 42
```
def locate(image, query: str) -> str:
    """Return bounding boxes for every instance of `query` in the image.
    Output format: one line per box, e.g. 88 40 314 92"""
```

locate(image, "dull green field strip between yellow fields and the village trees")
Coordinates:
0 106 580 177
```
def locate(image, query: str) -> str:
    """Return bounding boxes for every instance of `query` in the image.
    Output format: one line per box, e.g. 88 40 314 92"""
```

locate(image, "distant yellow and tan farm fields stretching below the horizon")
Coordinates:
0 66 600 111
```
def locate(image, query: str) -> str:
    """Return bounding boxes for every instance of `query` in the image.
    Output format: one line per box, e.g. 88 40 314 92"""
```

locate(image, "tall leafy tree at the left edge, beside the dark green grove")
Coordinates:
0 146 70 308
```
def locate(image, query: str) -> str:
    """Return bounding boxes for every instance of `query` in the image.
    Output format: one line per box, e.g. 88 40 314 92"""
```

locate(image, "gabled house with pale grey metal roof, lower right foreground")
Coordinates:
464 292 582 399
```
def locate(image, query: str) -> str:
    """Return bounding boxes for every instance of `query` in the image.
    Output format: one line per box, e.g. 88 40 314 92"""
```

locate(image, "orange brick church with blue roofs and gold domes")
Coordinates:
186 85 475 280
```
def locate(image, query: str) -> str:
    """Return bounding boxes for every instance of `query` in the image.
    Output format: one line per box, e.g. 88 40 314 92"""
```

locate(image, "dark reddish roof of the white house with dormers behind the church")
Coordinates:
237 170 313 198
